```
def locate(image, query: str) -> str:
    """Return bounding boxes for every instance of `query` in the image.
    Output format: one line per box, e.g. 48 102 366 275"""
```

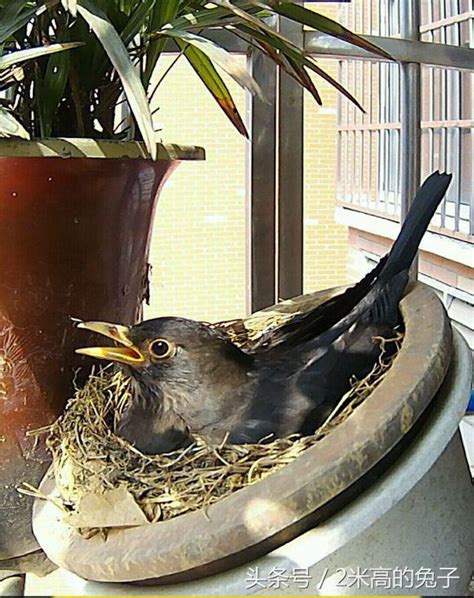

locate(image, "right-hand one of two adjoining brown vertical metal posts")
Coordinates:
277 5 304 299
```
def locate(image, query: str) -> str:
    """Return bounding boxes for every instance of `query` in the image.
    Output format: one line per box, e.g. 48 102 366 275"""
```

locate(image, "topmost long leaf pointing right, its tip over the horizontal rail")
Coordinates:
264 0 393 60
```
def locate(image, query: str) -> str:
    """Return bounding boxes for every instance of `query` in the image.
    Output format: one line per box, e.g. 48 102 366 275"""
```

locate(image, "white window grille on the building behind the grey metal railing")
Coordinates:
338 0 474 238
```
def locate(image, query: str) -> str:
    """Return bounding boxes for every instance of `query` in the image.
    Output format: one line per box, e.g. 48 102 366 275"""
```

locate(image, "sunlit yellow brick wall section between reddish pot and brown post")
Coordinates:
145 57 246 321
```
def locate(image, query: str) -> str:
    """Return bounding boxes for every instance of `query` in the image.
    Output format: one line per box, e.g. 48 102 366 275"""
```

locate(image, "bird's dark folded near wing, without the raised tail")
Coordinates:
243 272 408 441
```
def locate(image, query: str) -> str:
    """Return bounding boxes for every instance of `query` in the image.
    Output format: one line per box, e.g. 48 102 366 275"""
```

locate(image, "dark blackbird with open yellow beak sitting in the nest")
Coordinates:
76 171 452 454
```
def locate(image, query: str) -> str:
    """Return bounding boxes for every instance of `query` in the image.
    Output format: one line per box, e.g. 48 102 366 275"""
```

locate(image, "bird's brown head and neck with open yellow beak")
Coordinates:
76 317 251 414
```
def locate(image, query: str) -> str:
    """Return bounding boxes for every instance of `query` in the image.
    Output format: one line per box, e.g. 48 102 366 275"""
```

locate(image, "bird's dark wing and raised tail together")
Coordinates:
230 173 451 439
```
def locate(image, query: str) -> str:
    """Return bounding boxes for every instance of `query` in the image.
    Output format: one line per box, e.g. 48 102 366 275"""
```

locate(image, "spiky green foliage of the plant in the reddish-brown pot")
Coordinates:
0 0 388 156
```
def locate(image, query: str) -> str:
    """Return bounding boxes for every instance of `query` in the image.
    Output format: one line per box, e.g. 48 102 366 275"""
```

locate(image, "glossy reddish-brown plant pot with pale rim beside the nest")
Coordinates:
0 140 203 568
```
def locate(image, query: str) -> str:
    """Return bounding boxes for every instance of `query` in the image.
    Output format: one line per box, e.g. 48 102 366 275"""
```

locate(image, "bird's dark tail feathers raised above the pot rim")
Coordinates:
380 172 452 280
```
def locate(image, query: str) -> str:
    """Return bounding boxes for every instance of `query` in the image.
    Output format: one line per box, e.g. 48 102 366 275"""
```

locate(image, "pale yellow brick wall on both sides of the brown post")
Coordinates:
145 5 347 321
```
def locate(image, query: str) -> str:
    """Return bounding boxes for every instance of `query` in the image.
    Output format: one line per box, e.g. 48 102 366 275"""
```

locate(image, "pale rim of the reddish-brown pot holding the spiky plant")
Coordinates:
0 137 206 160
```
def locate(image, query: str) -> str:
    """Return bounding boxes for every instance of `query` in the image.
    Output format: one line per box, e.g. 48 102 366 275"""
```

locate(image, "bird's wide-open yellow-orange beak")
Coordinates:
76 322 145 365
